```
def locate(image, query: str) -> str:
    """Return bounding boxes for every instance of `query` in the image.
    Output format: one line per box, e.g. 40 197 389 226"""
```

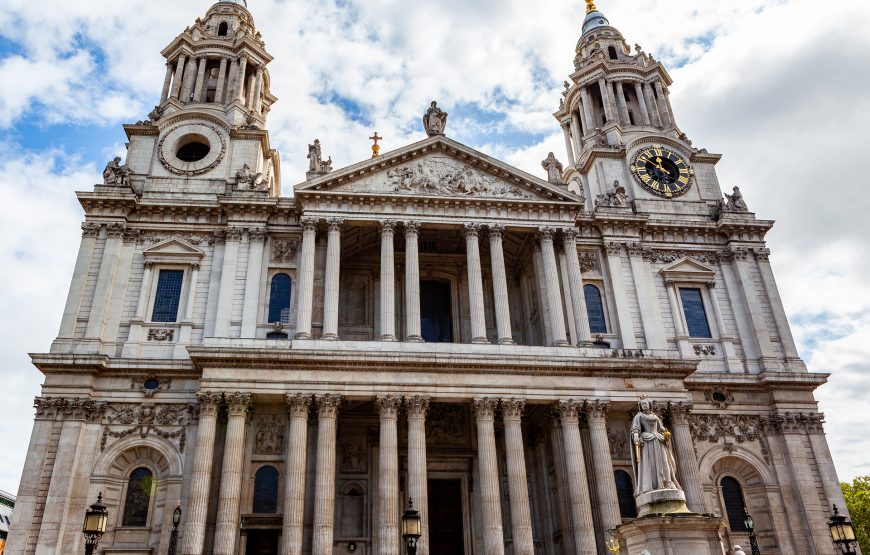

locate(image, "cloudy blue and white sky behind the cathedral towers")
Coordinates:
0 0 870 492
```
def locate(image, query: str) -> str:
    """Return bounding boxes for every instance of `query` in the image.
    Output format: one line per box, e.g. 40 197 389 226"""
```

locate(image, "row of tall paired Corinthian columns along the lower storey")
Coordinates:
181 393 704 555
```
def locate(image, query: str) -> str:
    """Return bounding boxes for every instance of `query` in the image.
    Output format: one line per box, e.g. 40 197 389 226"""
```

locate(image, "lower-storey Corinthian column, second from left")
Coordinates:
214 393 252 555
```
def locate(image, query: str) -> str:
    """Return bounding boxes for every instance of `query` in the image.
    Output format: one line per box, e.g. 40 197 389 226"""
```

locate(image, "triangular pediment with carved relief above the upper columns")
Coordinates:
295 136 581 203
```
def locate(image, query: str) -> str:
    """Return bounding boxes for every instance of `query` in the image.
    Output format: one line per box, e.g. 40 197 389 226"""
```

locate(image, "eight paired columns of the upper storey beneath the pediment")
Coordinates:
296 217 591 346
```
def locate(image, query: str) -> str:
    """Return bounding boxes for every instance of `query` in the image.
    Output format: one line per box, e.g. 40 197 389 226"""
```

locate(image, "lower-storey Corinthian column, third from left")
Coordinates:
281 393 311 555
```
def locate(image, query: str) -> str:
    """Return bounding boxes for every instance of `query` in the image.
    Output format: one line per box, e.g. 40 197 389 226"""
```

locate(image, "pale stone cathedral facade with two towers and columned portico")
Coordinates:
7 0 860 555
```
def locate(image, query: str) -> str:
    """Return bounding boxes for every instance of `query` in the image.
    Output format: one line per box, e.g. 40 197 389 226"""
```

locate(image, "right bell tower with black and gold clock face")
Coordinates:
554 0 722 216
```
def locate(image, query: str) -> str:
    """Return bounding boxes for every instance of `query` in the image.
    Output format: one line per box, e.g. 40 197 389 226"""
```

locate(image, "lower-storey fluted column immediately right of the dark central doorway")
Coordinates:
473 398 504 555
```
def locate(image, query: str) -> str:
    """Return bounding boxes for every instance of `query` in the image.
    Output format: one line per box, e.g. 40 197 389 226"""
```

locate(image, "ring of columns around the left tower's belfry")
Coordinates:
160 53 265 113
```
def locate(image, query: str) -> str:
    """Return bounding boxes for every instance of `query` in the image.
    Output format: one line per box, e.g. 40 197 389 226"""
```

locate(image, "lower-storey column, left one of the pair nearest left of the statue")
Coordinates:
556 400 598 555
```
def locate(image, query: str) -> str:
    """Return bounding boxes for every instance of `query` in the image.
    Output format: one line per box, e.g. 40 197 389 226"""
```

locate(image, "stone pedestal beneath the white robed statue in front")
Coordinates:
613 513 725 555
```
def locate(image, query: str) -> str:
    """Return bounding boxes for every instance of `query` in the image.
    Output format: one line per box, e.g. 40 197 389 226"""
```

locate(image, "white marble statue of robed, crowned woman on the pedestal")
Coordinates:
631 398 683 496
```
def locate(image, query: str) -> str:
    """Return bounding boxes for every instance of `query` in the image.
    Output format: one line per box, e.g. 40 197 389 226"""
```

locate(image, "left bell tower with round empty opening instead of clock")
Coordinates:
124 0 280 196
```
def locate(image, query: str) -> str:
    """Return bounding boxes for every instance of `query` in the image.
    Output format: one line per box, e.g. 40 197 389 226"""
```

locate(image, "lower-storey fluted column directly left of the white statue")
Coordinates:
586 401 622 538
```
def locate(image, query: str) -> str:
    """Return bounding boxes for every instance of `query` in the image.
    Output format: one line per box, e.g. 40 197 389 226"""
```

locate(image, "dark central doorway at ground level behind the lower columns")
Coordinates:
428 479 465 555
